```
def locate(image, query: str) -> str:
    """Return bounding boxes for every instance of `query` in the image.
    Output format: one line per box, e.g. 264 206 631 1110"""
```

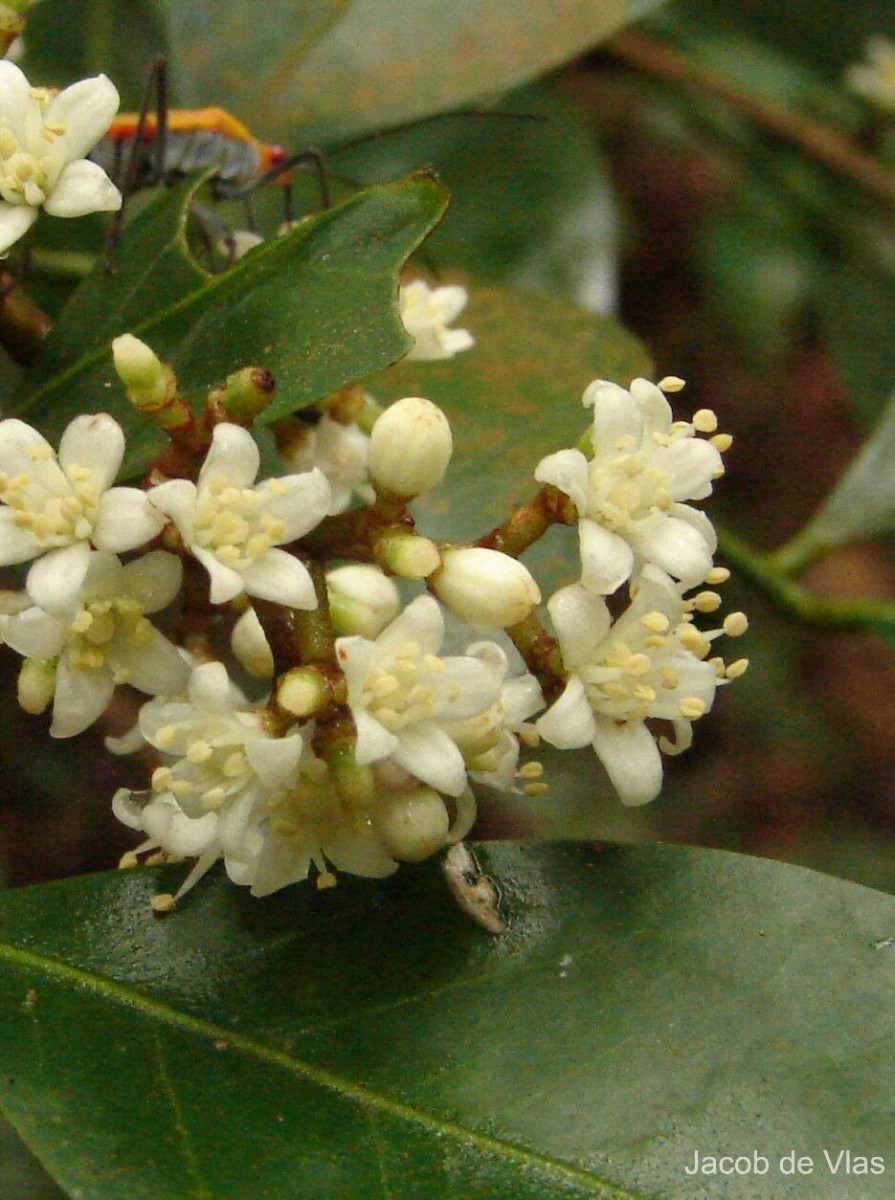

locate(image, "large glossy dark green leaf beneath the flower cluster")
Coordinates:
0 844 895 1200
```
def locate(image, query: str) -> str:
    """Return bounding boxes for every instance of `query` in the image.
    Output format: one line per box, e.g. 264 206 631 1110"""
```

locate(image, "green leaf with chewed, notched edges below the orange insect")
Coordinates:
8 174 446 475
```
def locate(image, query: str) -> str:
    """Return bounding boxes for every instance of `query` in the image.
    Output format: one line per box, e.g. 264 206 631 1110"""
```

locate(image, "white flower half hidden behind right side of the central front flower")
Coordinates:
446 642 543 792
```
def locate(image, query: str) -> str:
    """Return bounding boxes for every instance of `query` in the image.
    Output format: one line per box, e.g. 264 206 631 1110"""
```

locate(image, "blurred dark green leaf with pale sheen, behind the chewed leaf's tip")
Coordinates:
326 86 617 301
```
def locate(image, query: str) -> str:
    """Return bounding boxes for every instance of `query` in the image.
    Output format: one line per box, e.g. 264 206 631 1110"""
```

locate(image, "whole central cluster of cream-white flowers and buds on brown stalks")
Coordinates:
0 340 745 908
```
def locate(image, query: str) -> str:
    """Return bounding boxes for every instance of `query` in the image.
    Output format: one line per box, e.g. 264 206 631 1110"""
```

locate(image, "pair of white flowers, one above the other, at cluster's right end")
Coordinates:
535 377 746 805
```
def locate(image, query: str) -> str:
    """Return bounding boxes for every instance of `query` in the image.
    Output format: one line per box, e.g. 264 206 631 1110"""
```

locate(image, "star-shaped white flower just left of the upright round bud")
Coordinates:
149 422 330 608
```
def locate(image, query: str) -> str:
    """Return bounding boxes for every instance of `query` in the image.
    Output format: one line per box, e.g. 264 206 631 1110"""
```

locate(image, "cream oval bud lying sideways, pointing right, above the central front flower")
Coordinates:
430 546 541 629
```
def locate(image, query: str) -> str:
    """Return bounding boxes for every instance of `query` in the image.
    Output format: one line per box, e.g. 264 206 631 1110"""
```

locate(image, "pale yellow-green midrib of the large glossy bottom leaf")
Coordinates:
0 942 648 1200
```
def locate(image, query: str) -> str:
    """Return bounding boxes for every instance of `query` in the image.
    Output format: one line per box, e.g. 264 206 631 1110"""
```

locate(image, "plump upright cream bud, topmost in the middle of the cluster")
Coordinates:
370 396 453 499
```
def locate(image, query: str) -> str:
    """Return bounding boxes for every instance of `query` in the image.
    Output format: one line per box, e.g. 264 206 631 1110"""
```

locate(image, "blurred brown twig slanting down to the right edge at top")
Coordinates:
603 30 895 205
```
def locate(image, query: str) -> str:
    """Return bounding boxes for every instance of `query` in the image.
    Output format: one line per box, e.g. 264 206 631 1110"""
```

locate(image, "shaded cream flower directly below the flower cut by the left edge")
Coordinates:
4 550 190 738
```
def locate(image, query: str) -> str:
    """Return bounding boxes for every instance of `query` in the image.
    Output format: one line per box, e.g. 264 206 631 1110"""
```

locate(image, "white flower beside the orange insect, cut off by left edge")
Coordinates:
0 61 121 253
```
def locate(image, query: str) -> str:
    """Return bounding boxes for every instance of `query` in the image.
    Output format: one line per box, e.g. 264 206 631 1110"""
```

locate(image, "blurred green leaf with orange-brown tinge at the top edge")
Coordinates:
158 0 660 150
